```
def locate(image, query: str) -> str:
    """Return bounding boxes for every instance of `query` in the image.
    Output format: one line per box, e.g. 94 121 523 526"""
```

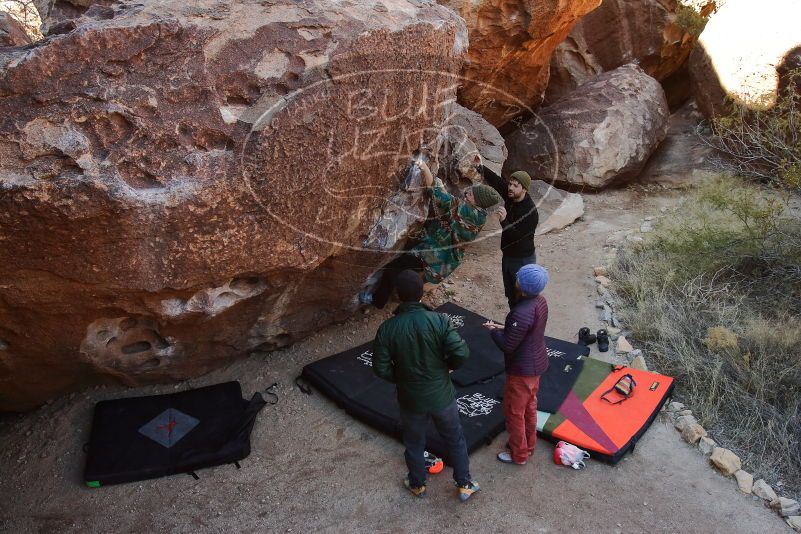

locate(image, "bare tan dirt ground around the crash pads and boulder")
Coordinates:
0 188 789 533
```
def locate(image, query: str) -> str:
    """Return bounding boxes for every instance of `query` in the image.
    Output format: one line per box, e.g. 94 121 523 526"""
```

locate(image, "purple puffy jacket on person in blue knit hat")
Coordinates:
490 295 548 376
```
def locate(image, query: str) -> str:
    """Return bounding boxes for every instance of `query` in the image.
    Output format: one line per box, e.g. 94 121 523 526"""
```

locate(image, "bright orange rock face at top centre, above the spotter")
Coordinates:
437 0 601 127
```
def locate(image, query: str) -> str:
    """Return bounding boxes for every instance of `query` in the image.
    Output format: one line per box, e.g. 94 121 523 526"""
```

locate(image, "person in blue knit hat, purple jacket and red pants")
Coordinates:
484 264 548 465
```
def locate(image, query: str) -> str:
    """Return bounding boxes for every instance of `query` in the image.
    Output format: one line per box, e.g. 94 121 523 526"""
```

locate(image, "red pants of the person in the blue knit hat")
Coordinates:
503 375 540 464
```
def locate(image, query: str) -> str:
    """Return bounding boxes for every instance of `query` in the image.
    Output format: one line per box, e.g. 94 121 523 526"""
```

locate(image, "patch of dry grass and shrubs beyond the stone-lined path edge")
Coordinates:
612 182 801 502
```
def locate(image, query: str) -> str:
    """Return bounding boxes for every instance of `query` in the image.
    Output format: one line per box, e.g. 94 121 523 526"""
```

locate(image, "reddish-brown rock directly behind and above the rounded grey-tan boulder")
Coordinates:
545 0 695 102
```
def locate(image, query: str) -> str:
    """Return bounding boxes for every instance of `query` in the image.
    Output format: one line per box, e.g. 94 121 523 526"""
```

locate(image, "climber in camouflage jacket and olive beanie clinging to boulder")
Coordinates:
366 161 506 309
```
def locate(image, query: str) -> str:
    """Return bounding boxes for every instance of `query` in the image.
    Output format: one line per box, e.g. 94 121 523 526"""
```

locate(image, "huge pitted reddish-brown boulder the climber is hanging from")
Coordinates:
0 0 466 410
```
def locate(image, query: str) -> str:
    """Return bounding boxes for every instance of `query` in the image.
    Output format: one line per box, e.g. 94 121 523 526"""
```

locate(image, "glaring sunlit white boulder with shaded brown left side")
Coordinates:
689 0 801 118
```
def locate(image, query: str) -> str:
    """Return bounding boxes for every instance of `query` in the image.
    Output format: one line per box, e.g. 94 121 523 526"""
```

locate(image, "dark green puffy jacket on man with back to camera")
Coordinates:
373 302 470 413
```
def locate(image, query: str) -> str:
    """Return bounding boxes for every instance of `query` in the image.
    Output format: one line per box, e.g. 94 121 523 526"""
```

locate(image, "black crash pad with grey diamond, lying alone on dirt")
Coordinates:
84 382 265 487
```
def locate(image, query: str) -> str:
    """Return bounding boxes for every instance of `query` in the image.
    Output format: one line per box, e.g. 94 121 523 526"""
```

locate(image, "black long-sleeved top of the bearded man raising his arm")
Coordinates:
479 166 540 258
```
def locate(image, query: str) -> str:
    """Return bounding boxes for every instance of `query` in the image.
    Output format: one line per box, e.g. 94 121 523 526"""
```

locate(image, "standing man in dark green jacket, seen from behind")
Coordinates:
373 269 480 501
